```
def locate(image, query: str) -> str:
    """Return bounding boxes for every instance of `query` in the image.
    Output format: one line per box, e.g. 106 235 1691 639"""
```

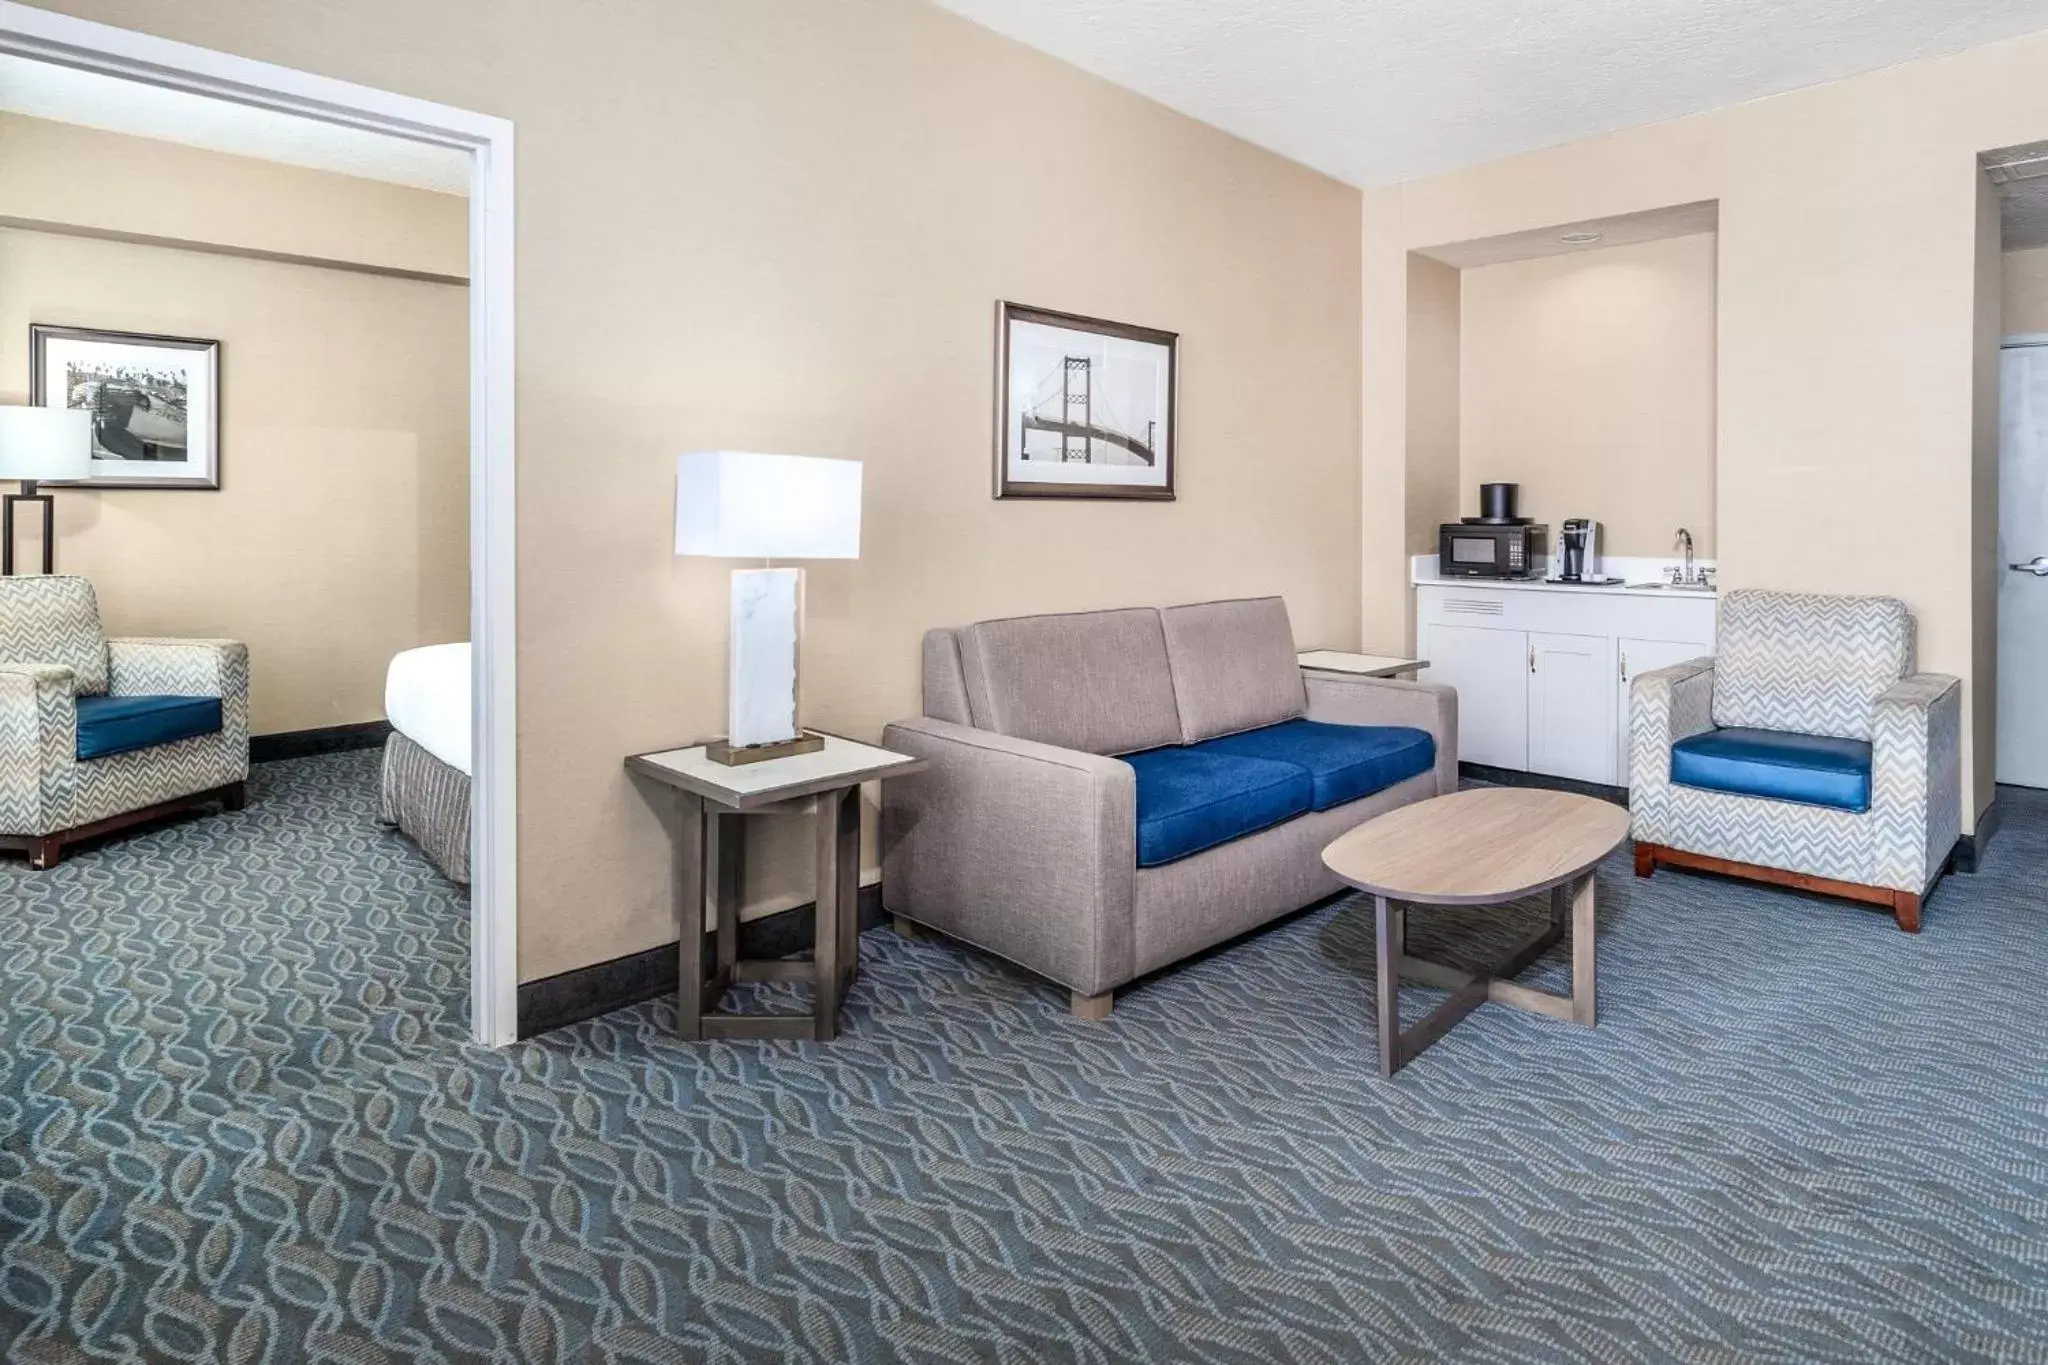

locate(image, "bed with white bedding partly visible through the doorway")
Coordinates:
381 645 471 884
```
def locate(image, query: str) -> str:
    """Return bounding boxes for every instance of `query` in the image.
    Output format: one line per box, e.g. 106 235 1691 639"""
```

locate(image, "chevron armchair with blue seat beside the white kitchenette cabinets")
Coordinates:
1628 591 1962 933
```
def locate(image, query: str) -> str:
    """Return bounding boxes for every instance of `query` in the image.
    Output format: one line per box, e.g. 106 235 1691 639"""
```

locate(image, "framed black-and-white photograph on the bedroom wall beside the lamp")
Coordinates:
29 323 221 489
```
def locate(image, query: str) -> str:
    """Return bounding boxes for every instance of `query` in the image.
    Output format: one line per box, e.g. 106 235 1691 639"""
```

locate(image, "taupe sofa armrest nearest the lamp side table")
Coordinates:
881 716 1137 995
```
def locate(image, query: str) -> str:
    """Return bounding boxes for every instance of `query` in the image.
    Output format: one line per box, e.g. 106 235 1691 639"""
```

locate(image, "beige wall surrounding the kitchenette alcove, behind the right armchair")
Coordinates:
1362 35 2048 829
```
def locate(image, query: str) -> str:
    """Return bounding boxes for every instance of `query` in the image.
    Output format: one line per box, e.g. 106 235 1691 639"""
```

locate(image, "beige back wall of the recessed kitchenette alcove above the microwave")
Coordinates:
1458 233 1714 555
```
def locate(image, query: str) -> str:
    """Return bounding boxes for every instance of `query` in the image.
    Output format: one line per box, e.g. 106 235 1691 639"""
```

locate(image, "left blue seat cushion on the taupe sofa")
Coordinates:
1124 749 1313 868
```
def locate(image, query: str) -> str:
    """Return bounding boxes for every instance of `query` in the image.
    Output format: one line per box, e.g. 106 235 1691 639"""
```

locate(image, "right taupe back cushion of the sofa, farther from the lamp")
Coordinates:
1159 598 1309 745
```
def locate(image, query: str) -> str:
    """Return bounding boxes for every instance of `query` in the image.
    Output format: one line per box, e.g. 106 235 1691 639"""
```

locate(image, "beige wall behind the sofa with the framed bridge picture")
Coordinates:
28 0 1359 980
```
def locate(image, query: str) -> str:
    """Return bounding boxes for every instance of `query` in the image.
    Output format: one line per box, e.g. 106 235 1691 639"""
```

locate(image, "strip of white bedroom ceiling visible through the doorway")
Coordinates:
0 55 469 194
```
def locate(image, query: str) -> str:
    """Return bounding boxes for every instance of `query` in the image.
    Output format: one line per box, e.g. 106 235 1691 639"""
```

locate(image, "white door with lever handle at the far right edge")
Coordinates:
1997 346 2048 786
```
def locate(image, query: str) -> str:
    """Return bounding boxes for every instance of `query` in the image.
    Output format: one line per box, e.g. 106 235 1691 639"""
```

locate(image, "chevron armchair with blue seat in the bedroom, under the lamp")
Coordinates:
0 575 250 870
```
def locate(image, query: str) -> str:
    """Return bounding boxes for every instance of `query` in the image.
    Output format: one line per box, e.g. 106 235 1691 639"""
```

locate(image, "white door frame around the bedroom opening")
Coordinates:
0 0 518 1046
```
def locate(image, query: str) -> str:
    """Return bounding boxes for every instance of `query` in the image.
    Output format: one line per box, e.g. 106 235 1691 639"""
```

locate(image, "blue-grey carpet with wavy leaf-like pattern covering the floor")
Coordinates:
0 753 2048 1365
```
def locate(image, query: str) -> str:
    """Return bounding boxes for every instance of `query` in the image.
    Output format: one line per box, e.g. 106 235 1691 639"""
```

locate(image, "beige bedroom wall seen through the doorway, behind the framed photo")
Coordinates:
0 117 469 735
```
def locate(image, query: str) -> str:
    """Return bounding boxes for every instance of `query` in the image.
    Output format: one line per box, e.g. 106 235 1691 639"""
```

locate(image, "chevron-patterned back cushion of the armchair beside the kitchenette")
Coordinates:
1714 589 1913 739
